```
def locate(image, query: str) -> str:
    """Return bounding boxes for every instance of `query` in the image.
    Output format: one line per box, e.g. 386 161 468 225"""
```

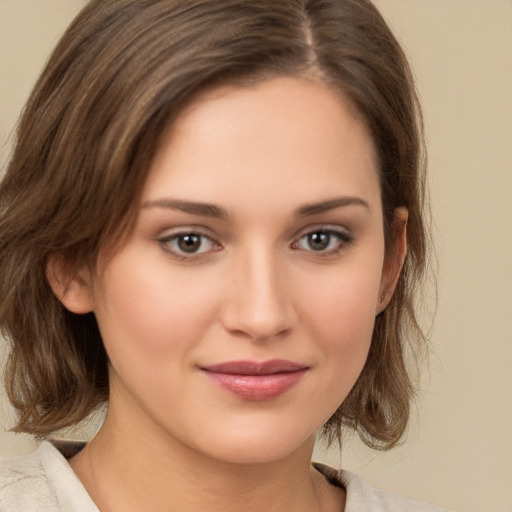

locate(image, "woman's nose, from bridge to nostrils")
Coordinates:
222 246 297 341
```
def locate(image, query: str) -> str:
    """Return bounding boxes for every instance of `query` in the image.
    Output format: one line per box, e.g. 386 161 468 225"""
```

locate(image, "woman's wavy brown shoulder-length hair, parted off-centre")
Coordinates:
0 0 428 449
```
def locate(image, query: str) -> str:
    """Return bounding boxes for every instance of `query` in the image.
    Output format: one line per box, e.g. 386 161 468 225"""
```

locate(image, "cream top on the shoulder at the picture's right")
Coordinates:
315 464 451 512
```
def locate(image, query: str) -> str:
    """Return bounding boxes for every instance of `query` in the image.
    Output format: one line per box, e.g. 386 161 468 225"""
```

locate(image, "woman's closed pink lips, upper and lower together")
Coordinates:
201 359 309 401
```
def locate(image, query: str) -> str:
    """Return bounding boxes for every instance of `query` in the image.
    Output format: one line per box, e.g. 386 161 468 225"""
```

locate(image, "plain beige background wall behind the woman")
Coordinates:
0 0 512 512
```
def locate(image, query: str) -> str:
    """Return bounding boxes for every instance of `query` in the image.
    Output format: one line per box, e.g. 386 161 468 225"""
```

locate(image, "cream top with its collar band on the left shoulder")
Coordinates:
0 442 98 512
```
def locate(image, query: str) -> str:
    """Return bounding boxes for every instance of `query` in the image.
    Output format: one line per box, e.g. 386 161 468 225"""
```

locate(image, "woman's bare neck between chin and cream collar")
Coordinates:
70 416 343 512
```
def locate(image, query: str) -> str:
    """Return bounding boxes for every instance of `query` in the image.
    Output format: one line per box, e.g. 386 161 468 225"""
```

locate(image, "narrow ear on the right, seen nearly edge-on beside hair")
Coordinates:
377 207 409 314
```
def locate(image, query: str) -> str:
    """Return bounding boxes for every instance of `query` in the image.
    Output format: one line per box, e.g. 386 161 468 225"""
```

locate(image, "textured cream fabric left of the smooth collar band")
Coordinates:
0 447 58 512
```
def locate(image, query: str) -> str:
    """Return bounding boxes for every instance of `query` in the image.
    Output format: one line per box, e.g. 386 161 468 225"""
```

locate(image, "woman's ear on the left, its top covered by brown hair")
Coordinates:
46 254 94 314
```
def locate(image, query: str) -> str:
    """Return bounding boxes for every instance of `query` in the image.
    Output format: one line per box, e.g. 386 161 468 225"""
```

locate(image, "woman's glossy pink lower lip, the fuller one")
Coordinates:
201 369 306 401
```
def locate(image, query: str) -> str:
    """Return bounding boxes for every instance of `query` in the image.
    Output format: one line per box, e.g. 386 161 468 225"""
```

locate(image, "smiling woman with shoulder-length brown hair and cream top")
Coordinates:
0 0 448 512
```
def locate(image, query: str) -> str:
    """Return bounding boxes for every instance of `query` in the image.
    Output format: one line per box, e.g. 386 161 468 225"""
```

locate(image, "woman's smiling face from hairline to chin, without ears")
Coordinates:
67 78 396 463
